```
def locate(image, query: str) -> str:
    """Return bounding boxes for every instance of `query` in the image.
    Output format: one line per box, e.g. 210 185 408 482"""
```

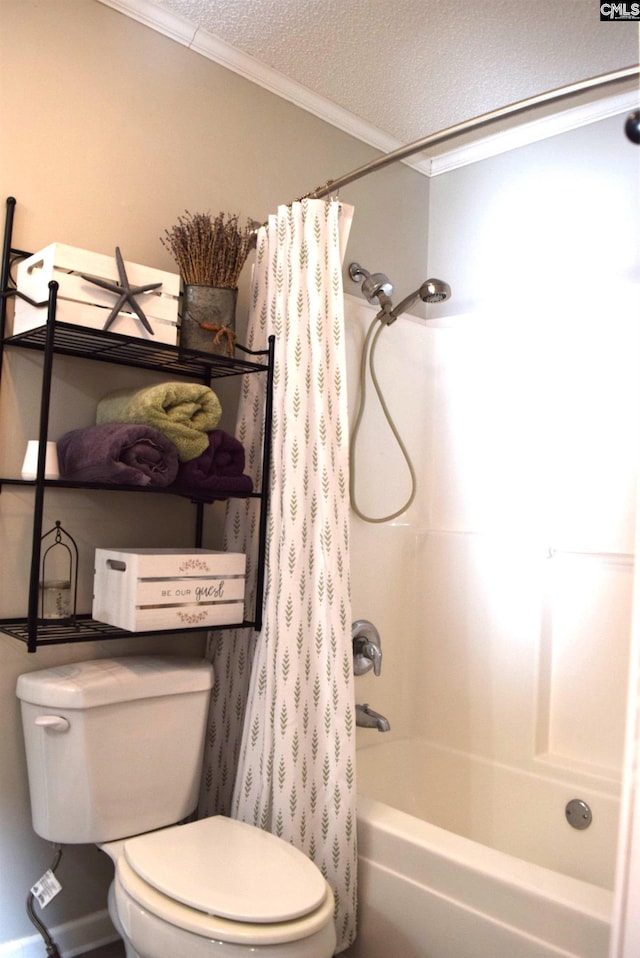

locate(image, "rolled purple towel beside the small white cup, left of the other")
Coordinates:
58 423 178 486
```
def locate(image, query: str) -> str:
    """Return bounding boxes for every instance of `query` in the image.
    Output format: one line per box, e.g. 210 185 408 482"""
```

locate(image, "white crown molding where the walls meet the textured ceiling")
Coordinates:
98 0 638 176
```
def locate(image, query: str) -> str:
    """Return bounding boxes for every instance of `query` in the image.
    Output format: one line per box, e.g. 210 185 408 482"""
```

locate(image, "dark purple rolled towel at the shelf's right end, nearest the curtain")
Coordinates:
175 429 253 498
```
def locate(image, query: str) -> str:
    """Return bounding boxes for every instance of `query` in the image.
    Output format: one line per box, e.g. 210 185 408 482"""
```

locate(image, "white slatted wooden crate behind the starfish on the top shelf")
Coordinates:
13 243 180 346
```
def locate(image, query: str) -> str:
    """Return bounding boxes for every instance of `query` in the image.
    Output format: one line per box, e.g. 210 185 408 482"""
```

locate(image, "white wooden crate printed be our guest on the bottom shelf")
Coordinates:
92 549 246 632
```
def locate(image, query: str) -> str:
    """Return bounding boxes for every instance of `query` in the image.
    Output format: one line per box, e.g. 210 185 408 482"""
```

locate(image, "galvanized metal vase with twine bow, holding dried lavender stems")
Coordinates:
180 285 238 356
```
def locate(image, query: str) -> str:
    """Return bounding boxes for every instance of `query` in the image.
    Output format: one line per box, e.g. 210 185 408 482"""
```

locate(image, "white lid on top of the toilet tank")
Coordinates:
16 655 213 709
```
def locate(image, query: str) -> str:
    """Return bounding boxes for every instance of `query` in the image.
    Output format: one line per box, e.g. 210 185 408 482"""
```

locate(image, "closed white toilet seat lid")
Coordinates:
124 816 326 924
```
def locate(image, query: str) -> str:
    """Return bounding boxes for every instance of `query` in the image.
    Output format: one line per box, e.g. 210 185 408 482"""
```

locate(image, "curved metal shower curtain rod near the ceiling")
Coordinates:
306 66 640 199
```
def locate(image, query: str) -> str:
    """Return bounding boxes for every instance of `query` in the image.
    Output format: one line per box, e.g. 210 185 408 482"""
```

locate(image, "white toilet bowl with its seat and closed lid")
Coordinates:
100 816 336 958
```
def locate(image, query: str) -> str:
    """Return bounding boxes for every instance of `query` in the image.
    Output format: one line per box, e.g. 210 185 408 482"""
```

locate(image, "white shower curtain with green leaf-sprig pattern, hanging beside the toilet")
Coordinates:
200 199 356 951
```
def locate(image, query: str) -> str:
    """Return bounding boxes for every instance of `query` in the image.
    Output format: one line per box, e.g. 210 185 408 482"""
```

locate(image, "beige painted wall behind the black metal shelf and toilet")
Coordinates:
0 0 428 945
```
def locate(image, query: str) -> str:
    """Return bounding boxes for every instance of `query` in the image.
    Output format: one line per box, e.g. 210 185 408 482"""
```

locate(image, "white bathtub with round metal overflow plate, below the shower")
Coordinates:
348 739 617 958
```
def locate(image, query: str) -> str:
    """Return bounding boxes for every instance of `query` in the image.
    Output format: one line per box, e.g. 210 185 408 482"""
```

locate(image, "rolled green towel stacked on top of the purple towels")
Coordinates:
96 382 222 462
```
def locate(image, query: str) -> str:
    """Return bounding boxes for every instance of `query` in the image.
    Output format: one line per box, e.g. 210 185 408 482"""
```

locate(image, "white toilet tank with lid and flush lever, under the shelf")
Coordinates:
16 656 213 844
